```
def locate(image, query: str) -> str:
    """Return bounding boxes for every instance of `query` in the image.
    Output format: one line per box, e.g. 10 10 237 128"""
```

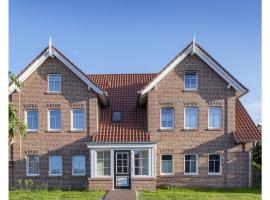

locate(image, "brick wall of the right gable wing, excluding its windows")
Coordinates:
147 55 251 187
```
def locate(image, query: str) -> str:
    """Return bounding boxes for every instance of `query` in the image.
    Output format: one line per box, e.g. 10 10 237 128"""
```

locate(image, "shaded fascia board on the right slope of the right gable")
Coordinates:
195 46 247 93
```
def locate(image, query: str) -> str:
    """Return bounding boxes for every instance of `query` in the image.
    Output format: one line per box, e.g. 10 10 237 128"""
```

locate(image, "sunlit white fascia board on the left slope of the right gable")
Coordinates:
140 45 192 96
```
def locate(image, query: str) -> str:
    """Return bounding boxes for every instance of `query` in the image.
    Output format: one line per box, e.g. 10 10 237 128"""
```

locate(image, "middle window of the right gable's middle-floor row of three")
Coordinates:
184 107 198 129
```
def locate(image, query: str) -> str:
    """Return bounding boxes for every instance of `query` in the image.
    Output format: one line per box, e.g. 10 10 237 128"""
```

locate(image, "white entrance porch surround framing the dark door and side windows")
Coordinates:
87 142 156 180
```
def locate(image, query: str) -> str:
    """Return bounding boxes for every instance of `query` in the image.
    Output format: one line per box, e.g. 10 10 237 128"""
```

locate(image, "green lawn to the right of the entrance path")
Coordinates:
139 188 262 200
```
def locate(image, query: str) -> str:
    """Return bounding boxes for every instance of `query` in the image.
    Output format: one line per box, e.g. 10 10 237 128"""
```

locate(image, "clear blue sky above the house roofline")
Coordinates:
9 0 261 123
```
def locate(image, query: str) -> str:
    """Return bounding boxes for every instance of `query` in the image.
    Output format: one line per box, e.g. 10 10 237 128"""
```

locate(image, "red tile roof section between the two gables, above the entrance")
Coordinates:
88 74 156 142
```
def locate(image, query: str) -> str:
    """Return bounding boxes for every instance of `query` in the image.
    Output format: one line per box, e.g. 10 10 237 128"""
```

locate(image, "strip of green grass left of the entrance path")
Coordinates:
9 190 106 200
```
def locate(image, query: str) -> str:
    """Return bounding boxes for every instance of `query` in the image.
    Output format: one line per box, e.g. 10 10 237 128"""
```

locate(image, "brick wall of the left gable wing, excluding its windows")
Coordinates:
10 58 98 187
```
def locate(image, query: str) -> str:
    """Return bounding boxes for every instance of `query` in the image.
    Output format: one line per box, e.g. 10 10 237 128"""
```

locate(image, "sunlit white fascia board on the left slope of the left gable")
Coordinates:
8 50 49 94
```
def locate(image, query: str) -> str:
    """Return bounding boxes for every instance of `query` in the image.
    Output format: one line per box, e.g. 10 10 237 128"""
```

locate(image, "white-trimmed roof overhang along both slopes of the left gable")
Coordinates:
8 46 108 106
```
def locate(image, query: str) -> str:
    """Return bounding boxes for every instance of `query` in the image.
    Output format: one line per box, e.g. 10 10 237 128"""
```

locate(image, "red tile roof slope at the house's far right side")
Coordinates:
233 99 261 143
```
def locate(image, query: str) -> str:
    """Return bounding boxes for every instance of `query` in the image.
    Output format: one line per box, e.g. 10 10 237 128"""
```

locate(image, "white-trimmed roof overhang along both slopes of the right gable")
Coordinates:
138 42 248 105
